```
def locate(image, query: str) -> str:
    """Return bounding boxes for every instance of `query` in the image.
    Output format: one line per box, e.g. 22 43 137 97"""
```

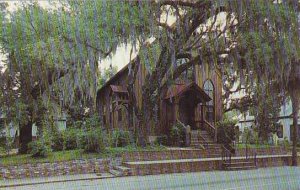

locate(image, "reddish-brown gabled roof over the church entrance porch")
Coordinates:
165 82 211 102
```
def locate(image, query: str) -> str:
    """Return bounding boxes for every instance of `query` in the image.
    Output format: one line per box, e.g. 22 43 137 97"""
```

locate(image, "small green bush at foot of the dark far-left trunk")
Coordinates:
28 139 52 158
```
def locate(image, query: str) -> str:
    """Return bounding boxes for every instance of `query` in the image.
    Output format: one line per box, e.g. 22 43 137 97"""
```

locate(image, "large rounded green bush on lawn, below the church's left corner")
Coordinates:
80 127 106 152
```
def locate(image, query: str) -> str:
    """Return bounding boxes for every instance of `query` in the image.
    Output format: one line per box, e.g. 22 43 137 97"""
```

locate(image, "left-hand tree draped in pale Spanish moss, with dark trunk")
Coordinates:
0 1 155 152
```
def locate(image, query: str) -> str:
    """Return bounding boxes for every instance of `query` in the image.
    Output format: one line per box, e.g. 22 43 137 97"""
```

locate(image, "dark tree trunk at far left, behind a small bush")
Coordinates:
19 122 32 154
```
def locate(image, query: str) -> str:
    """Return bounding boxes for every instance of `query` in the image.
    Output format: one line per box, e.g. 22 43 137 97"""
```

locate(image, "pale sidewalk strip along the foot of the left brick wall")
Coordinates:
0 173 114 189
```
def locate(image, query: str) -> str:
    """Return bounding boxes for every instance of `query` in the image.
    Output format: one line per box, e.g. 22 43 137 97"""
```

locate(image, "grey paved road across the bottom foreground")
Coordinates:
4 167 300 190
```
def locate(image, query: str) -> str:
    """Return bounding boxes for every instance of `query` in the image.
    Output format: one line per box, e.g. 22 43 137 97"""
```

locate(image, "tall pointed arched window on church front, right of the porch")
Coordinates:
203 80 215 122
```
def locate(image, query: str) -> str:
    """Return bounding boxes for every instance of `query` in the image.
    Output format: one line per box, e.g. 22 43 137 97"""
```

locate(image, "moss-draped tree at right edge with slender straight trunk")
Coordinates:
228 0 300 165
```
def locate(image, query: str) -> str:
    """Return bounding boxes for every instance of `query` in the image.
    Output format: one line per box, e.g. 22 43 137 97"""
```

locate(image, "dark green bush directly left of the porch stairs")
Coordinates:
170 123 185 146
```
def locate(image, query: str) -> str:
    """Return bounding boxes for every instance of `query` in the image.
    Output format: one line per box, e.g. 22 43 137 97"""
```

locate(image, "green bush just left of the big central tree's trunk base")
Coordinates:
110 129 133 147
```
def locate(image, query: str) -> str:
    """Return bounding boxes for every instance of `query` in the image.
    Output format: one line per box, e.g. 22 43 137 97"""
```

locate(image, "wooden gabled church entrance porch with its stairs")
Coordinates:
164 82 217 146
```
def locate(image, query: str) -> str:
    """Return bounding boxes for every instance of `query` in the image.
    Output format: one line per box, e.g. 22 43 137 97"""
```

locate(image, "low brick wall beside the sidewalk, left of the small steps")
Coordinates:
0 159 110 179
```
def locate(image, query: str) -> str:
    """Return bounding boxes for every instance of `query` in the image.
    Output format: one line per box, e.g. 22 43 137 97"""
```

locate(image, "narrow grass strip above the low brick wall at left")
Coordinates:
0 146 166 166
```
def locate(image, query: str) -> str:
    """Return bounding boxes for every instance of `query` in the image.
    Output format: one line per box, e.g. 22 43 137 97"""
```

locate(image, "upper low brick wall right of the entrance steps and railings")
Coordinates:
235 147 288 156
